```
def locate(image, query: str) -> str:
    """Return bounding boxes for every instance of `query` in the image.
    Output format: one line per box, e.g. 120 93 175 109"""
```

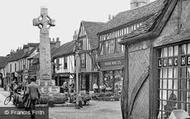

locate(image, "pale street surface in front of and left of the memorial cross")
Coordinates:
0 88 122 119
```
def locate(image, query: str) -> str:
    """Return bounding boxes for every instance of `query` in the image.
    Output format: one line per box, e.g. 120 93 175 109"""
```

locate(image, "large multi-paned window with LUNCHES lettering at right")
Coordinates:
158 44 190 119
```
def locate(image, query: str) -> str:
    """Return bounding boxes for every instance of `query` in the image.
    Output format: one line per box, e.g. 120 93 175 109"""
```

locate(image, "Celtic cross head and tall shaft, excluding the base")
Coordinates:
33 8 55 80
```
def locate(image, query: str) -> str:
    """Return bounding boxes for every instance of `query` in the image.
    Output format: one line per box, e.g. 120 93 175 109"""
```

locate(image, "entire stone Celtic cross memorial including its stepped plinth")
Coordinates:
33 8 59 95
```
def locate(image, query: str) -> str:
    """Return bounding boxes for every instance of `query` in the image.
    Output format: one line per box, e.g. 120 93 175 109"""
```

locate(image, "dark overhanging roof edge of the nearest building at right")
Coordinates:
120 0 178 44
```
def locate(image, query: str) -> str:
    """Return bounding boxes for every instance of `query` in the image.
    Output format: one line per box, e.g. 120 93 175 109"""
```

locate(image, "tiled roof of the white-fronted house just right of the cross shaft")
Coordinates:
52 40 75 59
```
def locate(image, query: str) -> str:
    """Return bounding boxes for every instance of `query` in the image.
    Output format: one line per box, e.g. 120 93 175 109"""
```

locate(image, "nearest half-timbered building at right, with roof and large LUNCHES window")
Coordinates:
121 0 190 119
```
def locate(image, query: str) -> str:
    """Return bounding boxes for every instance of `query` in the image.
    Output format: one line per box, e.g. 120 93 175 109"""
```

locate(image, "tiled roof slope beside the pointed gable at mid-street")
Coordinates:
81 21 105 49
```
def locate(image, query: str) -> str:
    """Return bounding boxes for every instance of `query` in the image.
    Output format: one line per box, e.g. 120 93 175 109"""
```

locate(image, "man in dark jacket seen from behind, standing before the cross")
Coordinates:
25 77 40 119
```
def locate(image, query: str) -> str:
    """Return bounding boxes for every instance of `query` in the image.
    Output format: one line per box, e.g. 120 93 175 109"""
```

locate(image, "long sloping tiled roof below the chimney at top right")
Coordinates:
99 0 164 33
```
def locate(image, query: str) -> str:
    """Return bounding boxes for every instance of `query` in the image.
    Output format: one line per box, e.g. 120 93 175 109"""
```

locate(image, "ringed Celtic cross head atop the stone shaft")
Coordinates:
33 8 55 33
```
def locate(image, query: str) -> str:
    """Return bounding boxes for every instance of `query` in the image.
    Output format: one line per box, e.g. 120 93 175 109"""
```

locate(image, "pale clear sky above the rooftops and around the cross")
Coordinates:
0 0 153 56
